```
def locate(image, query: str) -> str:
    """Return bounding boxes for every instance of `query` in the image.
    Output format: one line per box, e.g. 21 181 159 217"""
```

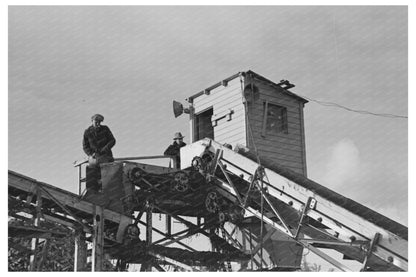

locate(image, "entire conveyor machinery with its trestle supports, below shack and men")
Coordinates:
9 139 408 271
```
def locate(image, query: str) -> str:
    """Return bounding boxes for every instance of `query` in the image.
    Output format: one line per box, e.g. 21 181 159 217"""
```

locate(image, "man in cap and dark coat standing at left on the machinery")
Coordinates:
82 114 116 191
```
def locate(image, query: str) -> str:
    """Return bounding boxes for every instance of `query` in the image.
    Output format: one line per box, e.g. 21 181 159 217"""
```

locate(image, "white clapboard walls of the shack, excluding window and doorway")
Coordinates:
191 71 306 176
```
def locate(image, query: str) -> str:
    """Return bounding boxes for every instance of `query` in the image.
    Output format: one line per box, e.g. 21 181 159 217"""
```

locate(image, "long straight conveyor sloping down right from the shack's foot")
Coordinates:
181 138 408 271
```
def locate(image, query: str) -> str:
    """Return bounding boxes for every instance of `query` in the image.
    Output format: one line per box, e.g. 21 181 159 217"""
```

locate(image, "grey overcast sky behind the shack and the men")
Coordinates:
8 6 408 229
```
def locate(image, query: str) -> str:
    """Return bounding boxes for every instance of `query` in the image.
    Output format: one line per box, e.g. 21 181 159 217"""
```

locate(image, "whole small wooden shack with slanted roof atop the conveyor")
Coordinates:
187 70 308 176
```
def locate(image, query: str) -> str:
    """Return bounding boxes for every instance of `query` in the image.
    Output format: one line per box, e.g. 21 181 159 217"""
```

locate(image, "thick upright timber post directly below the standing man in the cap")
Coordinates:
91 206 104 271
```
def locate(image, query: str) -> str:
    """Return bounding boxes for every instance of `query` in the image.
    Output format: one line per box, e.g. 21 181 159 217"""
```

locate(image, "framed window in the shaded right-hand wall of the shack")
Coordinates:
262 101 288 136
